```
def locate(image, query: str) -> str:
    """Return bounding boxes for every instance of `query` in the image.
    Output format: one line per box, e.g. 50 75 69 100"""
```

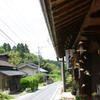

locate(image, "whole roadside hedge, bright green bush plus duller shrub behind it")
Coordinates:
20 73 45 91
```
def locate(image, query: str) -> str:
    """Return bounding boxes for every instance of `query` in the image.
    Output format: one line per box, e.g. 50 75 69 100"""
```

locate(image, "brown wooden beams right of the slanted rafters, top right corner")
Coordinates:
76 0 100 45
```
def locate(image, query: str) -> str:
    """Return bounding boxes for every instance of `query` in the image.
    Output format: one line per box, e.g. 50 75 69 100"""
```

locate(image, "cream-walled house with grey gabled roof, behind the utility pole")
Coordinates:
18 62 48 76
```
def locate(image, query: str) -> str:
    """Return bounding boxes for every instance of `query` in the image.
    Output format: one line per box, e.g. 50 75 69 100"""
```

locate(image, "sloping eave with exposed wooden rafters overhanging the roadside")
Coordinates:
40 0 92 58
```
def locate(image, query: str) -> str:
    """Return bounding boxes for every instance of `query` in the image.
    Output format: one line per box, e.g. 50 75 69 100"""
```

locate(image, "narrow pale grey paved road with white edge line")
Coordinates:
16 82 61 100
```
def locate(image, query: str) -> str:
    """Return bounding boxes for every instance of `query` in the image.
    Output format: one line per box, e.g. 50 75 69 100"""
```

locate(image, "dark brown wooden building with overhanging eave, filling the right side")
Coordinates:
40 0 100 100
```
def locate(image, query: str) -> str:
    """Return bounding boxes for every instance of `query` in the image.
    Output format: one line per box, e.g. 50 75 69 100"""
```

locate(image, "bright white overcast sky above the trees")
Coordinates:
0 0 56 60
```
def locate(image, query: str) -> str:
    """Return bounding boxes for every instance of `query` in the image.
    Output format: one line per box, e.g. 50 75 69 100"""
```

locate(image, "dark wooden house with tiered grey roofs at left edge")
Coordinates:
0 54 26 92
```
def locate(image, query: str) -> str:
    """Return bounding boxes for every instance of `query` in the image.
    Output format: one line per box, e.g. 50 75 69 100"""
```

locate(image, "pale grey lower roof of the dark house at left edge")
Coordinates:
0 70 26 76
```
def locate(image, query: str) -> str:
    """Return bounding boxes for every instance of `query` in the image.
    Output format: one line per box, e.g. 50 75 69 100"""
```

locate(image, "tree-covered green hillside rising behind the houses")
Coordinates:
0 43 60 76
